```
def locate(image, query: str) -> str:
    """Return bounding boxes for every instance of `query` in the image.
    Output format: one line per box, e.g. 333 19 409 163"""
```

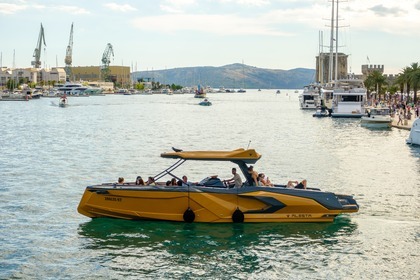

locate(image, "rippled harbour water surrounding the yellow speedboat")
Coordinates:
0 90 420 279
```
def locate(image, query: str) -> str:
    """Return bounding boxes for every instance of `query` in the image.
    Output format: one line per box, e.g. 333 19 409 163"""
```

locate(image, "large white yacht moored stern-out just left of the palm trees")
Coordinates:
331 79 367 118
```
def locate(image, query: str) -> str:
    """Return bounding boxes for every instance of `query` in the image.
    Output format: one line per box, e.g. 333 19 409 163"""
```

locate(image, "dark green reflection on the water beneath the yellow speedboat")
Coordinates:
79 216 357 254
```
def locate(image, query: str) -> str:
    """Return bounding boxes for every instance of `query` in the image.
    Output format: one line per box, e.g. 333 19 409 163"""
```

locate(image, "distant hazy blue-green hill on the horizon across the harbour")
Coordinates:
132 63 315 89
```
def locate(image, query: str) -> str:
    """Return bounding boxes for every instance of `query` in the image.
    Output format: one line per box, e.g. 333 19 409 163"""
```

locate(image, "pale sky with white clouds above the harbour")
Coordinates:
0 0 420 74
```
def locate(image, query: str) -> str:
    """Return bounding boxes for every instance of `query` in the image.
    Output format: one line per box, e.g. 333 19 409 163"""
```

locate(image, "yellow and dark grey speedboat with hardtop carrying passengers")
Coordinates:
77 149 359 223
